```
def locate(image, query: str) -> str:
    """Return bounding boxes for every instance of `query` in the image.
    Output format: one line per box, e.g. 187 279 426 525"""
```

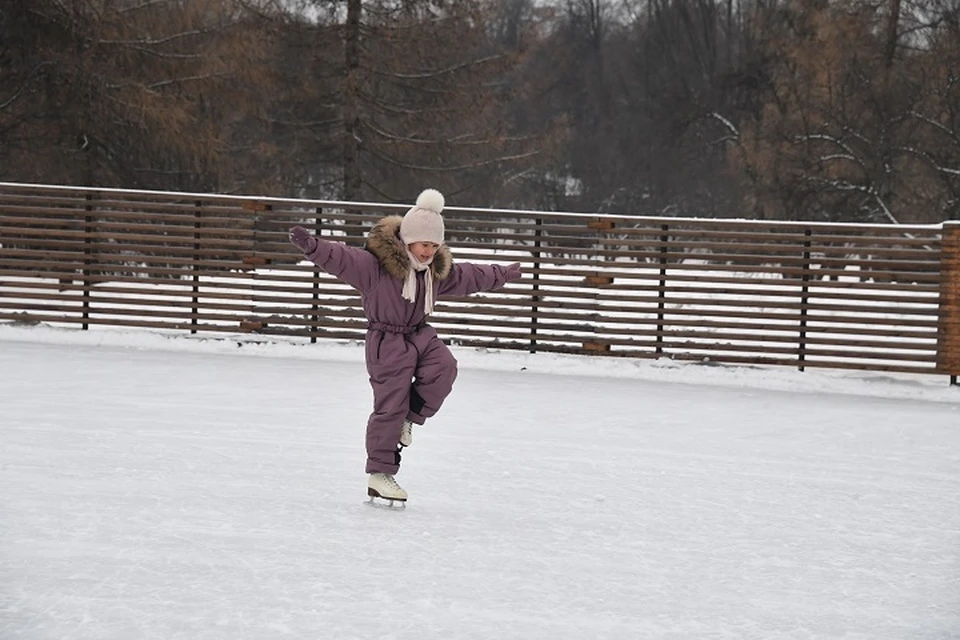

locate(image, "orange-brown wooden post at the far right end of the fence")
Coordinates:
937 222 960 386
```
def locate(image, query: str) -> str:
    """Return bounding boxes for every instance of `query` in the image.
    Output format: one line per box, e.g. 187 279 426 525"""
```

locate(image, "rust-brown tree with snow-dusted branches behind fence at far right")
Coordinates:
735 1 957 223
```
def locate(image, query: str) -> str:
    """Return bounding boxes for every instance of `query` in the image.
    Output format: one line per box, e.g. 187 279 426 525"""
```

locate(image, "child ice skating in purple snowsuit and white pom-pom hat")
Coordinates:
290 189 520 506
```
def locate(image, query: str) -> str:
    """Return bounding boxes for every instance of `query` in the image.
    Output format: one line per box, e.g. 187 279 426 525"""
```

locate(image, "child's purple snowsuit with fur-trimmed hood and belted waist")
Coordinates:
298 215 506 474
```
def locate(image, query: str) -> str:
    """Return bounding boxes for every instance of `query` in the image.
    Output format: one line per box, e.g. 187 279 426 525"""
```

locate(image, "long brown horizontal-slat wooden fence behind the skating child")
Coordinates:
0 183 960 383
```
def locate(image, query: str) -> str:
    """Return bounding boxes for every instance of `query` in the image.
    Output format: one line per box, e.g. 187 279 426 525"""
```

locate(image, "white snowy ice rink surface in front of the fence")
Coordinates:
0 326 960 640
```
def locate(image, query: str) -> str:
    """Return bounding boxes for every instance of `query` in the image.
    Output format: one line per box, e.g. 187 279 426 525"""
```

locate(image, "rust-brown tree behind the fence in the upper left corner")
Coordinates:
2 0 278 190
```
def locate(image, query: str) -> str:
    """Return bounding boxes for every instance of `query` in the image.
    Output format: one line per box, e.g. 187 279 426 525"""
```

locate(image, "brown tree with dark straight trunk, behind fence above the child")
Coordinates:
258 0 568 204
